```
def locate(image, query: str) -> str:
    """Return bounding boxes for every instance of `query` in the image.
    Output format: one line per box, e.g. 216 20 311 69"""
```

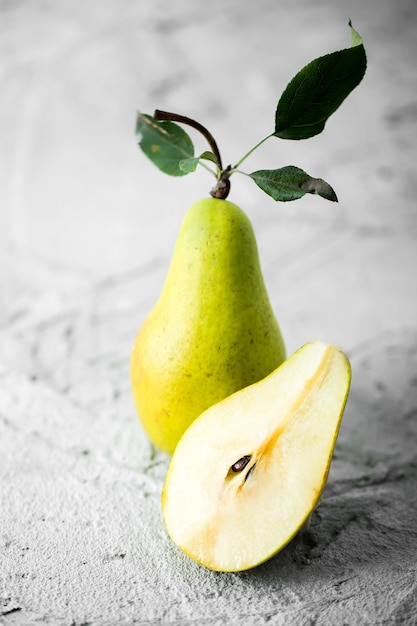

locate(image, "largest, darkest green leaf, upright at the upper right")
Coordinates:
273 22 366 139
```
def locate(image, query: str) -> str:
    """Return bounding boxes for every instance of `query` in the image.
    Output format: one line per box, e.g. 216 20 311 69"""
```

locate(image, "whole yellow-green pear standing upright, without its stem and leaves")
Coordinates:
131 198 285 454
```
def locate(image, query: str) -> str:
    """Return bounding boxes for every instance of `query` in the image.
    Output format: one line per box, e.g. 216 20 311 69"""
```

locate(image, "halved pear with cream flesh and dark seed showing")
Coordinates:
162 342 351 571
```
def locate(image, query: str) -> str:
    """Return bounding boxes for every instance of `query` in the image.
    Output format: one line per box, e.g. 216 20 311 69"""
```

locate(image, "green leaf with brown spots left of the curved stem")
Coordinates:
136 113 197 176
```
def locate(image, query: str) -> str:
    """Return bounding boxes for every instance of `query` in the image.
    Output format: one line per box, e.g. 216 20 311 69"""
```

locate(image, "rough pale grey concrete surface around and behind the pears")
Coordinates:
0 0 417 626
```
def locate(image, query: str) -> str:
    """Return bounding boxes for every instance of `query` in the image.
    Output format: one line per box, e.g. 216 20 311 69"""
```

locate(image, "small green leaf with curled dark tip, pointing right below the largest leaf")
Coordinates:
249 165 337 202
